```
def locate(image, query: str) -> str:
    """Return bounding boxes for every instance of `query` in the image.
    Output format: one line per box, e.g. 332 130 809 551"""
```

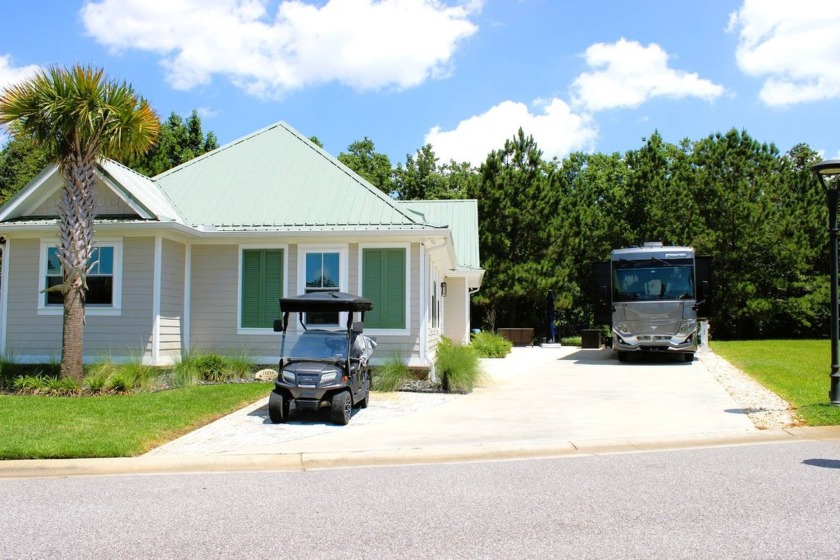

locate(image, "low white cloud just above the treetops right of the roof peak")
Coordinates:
424 99 598 166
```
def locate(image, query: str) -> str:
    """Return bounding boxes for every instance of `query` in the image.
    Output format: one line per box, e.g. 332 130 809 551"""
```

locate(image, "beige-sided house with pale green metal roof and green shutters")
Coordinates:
0 123 484 367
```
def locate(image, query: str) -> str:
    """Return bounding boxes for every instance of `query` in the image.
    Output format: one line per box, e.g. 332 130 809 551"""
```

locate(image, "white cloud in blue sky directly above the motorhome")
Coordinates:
571 39 724 111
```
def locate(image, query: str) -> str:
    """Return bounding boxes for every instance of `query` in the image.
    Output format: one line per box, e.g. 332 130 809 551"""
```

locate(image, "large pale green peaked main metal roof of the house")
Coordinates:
152 122 429 231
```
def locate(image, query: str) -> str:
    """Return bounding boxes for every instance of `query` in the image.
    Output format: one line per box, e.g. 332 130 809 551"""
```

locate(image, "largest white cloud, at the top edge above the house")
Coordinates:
81 0 481 97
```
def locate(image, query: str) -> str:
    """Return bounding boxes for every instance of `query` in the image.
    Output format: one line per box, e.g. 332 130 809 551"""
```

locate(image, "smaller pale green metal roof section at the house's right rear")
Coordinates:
398 199 481 270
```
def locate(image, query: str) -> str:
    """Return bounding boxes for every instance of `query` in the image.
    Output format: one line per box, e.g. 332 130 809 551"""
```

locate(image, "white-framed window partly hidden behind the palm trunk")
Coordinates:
38 242 122 314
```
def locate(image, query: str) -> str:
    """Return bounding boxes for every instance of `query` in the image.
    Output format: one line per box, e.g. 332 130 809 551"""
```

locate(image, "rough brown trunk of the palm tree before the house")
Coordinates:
58 154 96 379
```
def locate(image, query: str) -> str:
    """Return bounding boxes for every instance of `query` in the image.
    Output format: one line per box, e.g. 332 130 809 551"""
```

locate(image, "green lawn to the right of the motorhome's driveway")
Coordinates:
711 340 840 426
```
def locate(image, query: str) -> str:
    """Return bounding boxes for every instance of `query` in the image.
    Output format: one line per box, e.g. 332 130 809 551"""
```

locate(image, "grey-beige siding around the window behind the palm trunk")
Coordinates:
6 237 154 361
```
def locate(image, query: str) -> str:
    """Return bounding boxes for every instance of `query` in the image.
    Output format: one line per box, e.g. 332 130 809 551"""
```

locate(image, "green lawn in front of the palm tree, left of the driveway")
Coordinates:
0 383 272 459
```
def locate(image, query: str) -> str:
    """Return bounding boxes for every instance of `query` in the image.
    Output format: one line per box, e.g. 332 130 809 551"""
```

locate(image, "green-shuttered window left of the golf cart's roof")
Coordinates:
240 249 283 329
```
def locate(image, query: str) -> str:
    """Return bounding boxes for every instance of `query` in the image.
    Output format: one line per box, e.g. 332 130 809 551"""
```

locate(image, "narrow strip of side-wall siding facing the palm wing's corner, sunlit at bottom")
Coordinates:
160 239 186 362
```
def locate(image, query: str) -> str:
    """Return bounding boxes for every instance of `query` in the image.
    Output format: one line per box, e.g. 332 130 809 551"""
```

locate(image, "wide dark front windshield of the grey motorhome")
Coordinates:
613 260 694 301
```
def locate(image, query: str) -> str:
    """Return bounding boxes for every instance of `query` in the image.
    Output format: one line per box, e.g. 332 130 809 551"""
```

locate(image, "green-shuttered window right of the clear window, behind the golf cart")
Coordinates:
362 248 407 329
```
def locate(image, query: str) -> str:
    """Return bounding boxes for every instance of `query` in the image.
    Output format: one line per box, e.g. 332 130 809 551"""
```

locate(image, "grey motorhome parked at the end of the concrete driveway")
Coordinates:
595 242 711 362
